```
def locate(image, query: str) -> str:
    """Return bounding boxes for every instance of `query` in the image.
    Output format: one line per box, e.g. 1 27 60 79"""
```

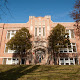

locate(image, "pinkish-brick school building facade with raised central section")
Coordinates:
0 16 80 65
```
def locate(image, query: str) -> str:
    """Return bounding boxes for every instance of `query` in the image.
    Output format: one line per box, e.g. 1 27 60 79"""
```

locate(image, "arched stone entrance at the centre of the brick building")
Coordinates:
33 46 47 64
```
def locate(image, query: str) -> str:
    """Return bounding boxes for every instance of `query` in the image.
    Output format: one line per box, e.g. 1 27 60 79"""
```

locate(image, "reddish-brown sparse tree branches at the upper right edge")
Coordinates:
70 0 80 37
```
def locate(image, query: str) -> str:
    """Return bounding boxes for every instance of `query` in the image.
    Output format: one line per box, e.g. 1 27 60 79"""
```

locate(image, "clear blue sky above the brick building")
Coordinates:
0 0 75 23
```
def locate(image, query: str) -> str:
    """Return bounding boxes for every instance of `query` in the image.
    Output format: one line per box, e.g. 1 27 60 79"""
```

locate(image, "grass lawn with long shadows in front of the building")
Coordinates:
0 65 80 80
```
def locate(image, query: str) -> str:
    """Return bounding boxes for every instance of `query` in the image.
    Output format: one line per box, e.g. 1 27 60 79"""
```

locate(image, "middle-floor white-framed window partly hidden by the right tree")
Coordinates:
60 43 77 53
